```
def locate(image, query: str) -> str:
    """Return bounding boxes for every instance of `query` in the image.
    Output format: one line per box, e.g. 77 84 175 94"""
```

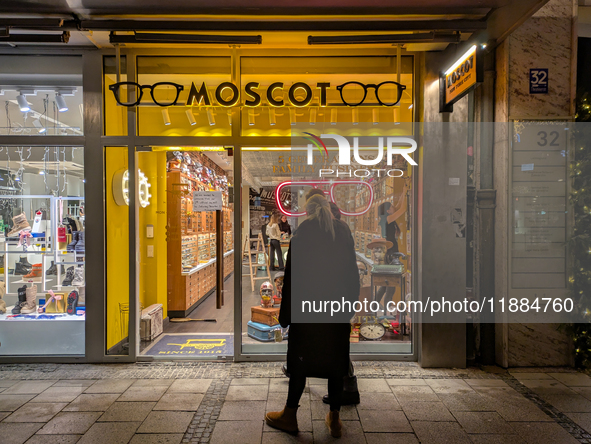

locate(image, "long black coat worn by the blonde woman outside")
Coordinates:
279 220 360 378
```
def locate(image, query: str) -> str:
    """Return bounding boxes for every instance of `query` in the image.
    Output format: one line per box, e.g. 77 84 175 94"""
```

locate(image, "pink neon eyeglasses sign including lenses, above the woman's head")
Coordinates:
275 180 373 217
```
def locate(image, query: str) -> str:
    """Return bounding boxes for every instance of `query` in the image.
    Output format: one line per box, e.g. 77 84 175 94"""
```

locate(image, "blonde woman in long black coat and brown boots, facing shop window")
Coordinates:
265 195 359 438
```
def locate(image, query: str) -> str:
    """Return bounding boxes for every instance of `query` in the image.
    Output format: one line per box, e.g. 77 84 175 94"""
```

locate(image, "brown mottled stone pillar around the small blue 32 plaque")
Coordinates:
493 0 577 367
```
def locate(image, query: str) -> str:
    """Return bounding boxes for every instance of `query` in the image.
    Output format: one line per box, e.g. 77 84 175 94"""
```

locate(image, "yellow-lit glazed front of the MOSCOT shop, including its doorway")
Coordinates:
104 53 414 359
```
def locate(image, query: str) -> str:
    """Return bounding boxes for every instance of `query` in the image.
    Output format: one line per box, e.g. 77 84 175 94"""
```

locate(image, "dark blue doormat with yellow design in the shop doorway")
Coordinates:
142 333 234 357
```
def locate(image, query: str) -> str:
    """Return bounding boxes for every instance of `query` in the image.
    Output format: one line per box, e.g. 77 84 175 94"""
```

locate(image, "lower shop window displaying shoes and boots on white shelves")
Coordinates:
0 146 87 356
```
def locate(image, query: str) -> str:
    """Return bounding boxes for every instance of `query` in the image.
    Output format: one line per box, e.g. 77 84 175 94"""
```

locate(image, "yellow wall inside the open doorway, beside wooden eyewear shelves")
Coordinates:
138 151 168 317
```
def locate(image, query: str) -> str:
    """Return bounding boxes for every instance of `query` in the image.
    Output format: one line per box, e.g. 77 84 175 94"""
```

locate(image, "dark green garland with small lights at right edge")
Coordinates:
568 93 591 369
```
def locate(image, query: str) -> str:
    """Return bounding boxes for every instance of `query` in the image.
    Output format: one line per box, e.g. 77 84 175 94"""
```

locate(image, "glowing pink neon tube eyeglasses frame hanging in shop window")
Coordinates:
275 180 373 217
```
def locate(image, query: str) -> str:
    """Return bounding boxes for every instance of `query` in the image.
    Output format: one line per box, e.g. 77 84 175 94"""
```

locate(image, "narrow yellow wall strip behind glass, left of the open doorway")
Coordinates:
105 147 129 349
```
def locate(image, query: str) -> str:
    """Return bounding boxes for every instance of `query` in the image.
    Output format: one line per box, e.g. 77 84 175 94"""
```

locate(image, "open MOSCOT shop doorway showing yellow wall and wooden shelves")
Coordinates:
135 147 234 359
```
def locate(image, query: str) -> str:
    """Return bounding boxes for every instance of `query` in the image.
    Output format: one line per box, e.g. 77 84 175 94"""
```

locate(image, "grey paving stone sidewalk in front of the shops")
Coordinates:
0 361 591 444
